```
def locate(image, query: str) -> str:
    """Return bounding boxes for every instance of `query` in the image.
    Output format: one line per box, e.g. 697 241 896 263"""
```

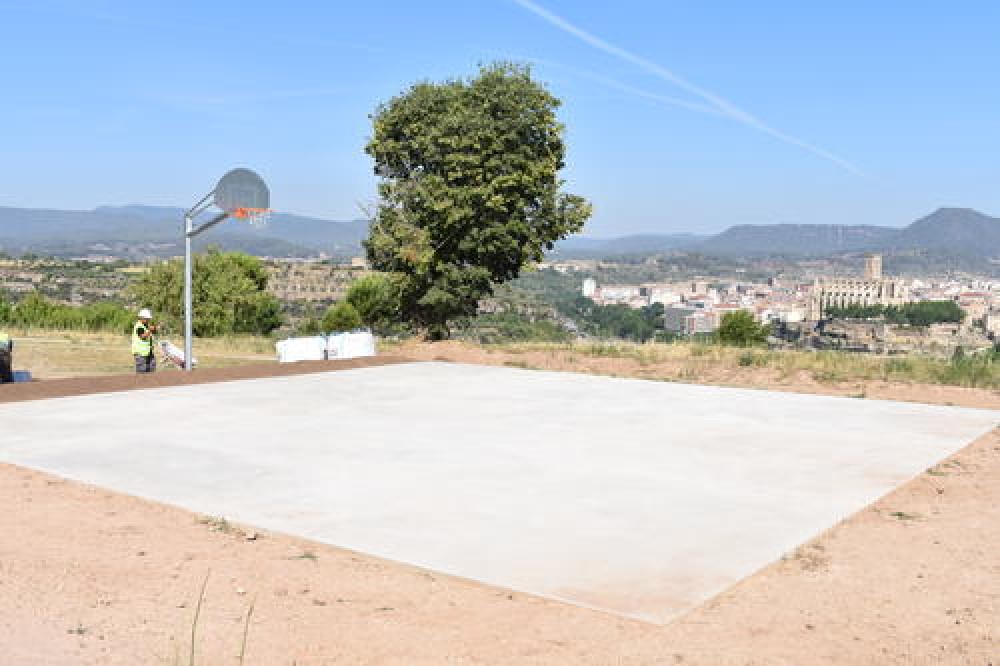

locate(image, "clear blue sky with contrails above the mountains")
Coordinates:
0 0 1000 236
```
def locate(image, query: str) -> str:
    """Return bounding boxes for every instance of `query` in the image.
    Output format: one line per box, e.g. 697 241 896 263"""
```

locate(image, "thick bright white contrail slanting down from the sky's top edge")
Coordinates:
512 0 864 176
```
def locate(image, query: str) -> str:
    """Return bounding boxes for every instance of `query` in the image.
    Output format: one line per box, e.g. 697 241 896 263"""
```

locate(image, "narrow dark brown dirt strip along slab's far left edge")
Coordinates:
0 355 412 404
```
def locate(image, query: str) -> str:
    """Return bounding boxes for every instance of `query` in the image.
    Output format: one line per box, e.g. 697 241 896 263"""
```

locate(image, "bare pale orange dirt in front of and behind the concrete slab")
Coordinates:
0 345 1000 666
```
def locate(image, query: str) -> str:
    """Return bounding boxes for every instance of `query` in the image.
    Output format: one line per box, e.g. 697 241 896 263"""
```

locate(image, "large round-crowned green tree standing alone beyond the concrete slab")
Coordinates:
365 63 591 338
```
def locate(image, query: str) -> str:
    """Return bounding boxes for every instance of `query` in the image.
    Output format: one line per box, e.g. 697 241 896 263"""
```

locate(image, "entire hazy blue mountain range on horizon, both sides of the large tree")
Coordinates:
0 206 1000 259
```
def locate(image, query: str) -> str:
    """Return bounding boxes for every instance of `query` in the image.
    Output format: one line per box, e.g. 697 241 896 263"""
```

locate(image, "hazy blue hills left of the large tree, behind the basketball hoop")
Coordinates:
0 206 368 257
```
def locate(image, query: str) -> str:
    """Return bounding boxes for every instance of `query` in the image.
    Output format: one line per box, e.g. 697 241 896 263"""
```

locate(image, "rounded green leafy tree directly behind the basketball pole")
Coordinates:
130 249 282 337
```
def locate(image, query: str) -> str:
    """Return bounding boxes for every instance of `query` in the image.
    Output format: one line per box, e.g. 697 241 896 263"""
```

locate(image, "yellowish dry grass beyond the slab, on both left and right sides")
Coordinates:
10 329 1000 391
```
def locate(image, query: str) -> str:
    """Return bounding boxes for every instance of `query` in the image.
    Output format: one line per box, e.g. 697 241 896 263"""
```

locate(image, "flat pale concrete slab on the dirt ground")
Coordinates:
0 363 1000 622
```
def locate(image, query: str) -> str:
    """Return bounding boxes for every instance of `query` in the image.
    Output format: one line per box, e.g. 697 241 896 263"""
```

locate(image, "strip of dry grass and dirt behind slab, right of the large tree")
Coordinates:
383 340 1000 409
